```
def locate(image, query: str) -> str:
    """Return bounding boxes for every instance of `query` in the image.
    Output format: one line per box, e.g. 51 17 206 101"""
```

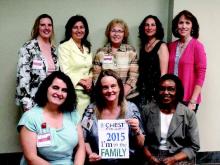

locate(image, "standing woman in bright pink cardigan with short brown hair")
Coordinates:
168 10 207 111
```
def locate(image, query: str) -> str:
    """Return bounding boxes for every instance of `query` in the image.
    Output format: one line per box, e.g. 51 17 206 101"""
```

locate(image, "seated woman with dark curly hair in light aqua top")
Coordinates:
18 71 85 165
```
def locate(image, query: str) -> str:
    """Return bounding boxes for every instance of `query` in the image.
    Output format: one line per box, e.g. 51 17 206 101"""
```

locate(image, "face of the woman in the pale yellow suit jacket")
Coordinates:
72 21 86 42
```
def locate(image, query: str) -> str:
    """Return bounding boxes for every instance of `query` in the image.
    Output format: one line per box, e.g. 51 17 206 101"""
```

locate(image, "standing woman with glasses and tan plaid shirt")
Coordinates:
93 19 138 101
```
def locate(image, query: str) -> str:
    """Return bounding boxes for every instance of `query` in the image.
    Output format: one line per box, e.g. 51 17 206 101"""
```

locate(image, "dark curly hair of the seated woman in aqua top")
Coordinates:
34 71 77 112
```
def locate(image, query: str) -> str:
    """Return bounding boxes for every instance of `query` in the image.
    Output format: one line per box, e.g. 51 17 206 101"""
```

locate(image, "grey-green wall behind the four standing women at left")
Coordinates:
0 0 169 153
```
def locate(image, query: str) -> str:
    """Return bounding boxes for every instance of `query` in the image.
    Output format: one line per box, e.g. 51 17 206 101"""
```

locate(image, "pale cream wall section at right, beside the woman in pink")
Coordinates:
173 0 220 151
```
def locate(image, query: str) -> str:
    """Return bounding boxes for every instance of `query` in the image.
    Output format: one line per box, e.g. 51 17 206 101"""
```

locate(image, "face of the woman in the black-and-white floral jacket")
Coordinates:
38 18 53 39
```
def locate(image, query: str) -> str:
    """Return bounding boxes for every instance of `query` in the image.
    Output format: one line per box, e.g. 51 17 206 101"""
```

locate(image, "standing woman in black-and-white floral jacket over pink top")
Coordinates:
16 14 59 111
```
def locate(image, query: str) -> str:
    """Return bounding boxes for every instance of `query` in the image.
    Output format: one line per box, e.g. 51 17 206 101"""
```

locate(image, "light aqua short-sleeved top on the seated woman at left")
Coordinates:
17 106 80 165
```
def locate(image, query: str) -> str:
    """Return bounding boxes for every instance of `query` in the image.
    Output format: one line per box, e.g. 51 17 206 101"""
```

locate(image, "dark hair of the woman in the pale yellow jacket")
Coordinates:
60 15 91 52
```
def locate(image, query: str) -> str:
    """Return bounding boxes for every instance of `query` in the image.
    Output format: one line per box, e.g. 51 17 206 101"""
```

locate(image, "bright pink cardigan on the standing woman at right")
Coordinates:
168 38 207 104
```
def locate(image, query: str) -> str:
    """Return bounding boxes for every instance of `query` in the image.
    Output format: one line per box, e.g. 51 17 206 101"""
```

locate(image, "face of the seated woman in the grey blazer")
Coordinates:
159 80 176 104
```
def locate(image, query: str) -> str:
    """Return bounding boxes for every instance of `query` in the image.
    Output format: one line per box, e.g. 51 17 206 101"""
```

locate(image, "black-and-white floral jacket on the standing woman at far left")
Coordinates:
15 39 59 111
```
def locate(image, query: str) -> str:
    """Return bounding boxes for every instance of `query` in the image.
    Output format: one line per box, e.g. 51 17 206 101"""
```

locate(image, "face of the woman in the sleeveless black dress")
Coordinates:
144 18 157 37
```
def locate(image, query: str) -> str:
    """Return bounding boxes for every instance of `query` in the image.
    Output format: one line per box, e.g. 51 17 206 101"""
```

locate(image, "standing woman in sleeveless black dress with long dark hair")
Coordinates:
137 15 169 106
